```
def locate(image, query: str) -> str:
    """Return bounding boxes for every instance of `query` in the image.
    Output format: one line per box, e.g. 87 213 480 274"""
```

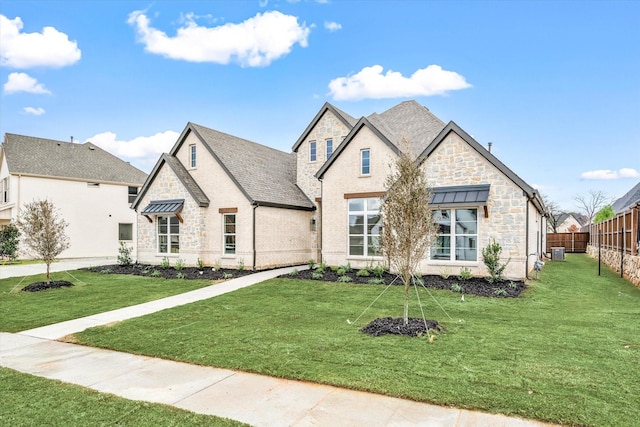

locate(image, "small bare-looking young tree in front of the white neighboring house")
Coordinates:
17 200 69 283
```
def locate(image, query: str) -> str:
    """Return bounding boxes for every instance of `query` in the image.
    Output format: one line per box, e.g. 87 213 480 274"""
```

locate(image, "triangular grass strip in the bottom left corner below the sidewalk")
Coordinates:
0 368 245 427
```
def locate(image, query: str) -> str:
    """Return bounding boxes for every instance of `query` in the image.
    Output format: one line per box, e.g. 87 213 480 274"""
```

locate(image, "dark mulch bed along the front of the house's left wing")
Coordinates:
86 263 253 280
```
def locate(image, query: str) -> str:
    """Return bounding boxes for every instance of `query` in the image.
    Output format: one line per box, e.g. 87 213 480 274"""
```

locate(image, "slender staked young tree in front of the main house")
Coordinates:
381 138 438 325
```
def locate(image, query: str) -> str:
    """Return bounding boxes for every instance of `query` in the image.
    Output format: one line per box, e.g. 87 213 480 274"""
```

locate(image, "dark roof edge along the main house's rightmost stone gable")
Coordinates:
417 121 544 213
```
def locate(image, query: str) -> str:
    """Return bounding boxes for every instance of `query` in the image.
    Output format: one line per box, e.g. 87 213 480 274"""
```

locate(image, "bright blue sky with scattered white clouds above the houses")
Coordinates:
0 0 640 210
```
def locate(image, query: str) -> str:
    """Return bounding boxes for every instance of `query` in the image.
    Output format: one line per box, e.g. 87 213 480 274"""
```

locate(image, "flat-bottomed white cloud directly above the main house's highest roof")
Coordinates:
329 65 471 101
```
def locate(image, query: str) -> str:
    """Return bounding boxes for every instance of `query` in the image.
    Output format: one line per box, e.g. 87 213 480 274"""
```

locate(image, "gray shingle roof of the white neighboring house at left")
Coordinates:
2 133 147 185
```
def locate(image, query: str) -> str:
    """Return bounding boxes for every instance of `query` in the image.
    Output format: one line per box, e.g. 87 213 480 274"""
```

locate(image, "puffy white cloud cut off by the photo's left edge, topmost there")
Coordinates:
0 15 81 69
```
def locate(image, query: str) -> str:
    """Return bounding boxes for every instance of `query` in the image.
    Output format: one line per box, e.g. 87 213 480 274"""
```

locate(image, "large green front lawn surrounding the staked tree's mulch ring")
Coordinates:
76 254 640 426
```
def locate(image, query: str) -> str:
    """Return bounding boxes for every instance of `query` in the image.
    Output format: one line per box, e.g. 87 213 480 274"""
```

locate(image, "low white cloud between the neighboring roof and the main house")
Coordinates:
85 130 180 171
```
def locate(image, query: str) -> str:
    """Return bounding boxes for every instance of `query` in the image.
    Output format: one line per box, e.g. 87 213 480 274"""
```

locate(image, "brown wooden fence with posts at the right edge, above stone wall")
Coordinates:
588 207 640 255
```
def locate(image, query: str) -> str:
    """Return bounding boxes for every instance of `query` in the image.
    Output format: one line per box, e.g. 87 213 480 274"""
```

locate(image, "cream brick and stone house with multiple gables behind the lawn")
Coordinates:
132 101 546 278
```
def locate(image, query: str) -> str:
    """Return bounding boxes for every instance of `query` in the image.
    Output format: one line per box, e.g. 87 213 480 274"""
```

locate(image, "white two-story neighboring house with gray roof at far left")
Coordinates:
0 133 147 258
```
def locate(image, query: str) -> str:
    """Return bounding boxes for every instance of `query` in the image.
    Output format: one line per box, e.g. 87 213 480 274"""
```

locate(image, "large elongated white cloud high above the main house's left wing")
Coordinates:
127 11 311 67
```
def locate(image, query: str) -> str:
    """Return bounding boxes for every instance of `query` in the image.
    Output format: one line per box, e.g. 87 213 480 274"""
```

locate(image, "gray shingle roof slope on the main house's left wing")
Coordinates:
188 123 315 210
